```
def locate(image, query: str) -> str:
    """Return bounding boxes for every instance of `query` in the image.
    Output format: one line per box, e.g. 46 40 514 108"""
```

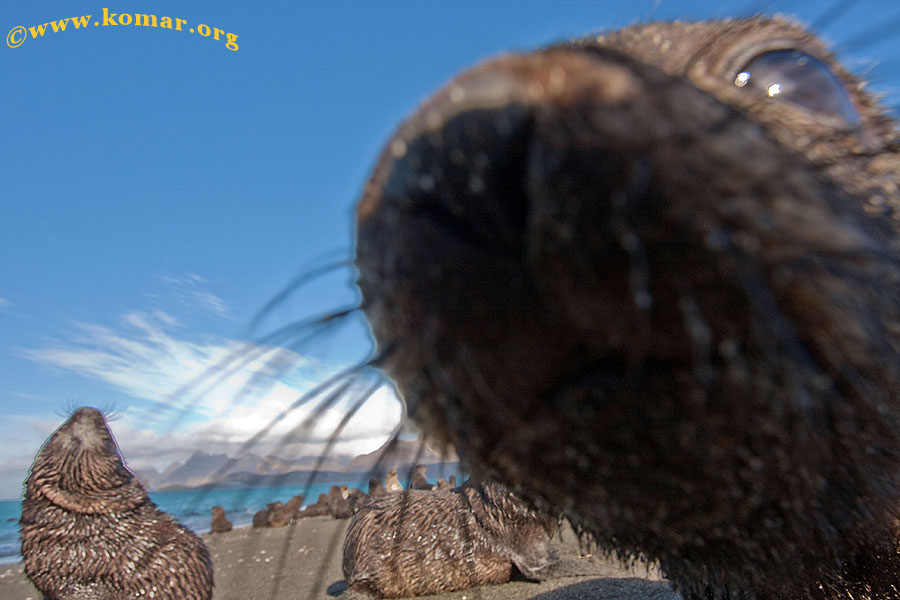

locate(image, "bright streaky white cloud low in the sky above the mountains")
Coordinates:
18 311 402 476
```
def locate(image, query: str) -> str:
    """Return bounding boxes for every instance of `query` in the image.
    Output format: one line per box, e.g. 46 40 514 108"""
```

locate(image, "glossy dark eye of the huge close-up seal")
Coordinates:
734 49 859 125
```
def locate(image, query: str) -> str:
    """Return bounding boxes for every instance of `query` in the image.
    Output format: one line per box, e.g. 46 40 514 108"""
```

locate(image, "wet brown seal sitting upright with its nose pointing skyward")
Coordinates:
21 408 213 600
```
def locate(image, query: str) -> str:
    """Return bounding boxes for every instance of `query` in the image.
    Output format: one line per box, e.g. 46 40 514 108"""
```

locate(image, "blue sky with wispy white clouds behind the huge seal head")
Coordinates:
0 0 900 498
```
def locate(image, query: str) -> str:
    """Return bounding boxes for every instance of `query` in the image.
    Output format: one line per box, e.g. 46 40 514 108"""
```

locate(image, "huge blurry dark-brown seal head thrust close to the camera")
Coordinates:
356 18 900 600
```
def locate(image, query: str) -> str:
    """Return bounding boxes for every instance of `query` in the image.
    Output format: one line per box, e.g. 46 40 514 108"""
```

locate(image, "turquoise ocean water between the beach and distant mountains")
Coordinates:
0 471 458 563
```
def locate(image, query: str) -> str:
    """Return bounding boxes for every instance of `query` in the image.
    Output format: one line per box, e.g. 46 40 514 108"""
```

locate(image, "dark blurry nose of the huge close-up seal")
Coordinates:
357 48 648 344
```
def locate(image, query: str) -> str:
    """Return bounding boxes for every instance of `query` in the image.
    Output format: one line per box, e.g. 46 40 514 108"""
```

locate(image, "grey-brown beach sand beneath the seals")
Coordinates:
0 517 680 600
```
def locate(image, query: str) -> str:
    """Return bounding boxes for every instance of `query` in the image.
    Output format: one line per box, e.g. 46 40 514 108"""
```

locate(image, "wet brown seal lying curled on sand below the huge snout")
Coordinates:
343 483 555 598
